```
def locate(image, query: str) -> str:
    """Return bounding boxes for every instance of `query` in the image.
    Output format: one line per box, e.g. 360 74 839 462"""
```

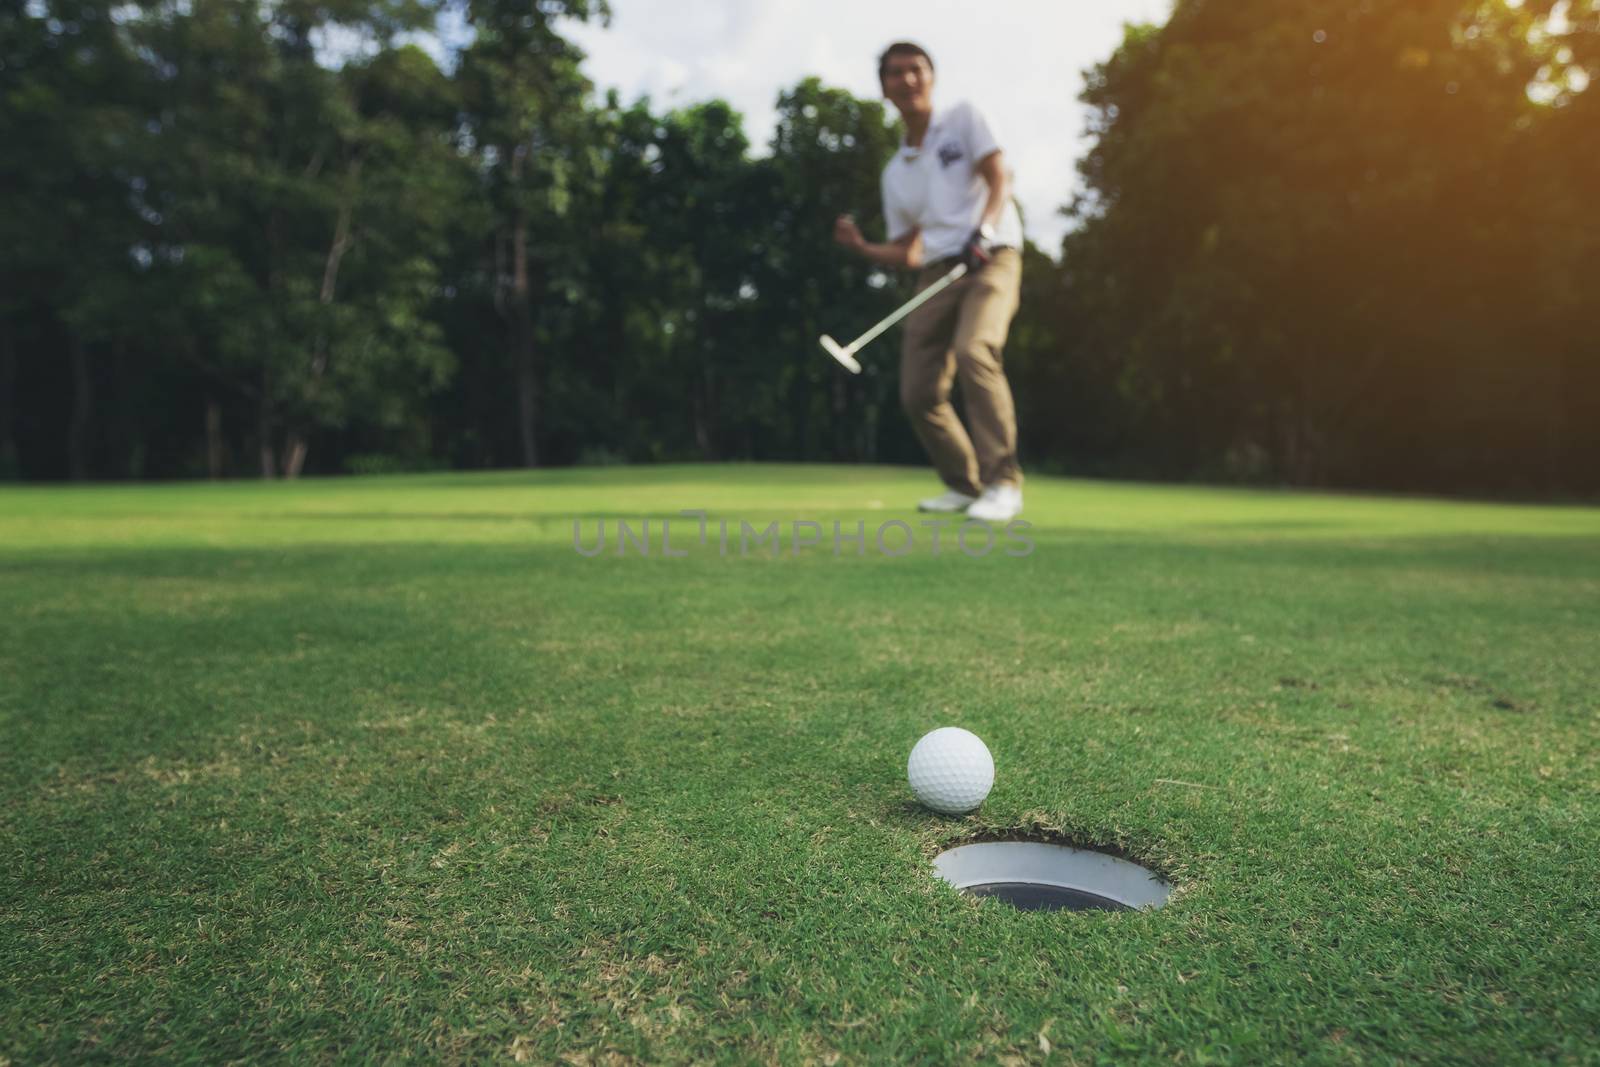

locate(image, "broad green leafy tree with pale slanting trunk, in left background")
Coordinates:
130 0 453 477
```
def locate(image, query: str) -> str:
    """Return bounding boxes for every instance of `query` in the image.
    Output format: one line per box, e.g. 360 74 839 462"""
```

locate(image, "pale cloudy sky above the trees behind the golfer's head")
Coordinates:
566 0 1171 253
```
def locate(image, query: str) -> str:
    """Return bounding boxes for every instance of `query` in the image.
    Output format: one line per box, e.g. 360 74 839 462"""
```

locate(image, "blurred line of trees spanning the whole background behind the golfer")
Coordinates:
0 0 1600 494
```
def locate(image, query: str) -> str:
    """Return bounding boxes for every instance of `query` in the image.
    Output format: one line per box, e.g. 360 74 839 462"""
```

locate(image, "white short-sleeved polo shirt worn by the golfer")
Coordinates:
883 102 1022 262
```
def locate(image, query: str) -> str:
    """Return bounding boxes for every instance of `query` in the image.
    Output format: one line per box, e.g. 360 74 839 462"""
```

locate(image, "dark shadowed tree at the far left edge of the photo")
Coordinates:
0 0 149 478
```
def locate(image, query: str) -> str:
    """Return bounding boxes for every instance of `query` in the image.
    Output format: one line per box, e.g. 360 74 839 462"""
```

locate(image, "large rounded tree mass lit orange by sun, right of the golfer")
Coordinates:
1066 0 1595 490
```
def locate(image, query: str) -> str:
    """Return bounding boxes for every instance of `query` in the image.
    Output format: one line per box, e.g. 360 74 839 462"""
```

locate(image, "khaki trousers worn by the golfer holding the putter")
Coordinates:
901 248 1022 496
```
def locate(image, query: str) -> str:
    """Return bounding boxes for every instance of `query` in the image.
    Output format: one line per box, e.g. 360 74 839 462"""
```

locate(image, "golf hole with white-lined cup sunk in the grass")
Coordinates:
933 841 1173 912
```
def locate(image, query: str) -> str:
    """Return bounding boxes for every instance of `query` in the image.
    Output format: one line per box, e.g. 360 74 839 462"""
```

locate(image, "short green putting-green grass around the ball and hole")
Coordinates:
0 466 1600 1067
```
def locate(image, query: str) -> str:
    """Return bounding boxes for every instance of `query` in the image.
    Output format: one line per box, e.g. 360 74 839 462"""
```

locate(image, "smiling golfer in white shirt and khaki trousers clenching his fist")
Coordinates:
834 42 1022 523
